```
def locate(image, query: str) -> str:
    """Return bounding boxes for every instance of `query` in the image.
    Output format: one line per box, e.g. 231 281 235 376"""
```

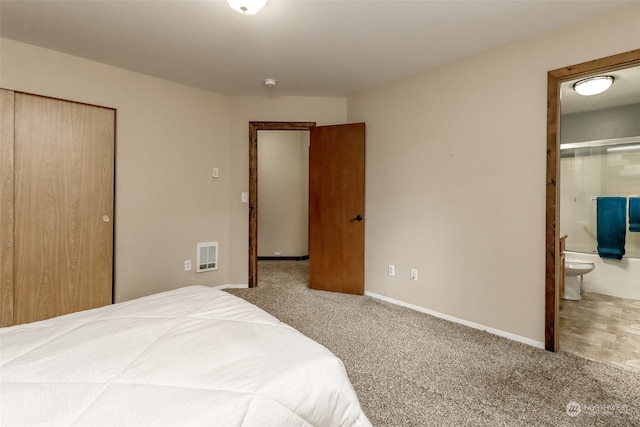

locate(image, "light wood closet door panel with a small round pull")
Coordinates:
13 93 115 324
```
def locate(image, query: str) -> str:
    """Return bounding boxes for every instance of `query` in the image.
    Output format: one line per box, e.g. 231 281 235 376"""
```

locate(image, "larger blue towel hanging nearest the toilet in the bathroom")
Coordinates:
597 197 627 259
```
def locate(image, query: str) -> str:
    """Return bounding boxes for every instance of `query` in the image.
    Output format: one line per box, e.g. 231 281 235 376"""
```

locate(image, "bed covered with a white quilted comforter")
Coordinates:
0 286 371 427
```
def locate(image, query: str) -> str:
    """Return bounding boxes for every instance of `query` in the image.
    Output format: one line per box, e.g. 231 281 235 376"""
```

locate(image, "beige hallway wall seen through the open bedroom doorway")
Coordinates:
258 130 309 257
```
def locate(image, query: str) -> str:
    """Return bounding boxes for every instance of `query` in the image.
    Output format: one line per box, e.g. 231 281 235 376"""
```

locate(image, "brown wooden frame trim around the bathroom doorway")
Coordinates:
545 50 640 351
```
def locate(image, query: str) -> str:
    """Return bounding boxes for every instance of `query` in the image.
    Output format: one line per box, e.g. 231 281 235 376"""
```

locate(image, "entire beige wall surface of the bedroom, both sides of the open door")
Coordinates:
0 0 640 342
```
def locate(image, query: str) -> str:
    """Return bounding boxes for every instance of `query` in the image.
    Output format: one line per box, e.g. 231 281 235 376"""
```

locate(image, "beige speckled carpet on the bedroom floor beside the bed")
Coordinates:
228 261 640 427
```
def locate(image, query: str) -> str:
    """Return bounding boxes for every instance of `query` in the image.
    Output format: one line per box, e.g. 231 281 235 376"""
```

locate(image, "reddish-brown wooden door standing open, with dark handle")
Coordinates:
309 123 365 295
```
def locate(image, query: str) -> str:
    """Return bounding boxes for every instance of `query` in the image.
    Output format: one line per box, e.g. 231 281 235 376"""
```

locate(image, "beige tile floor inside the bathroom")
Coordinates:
560 292 640 372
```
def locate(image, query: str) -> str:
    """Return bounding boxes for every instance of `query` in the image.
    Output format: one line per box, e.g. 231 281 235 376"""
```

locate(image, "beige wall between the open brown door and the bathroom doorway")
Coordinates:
348 4 640 343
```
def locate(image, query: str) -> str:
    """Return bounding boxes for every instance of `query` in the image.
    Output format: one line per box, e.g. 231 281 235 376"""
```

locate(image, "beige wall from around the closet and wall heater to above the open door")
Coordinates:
0 39 346 301
